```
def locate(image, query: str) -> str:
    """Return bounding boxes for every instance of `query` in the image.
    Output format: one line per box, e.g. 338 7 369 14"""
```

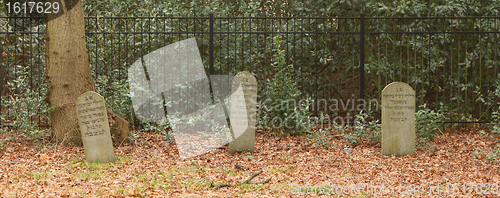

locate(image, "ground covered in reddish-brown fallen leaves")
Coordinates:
0 129 500 197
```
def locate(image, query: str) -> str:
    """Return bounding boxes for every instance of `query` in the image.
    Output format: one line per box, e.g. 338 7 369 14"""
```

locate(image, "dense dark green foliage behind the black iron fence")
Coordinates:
0 0 500 137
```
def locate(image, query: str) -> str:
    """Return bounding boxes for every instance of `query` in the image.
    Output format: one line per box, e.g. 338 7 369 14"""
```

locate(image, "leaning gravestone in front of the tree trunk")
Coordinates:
76 91 115 162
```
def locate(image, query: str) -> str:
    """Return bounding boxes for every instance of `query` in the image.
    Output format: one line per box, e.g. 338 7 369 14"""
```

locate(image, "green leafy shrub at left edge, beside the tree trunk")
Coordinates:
2 65 54 141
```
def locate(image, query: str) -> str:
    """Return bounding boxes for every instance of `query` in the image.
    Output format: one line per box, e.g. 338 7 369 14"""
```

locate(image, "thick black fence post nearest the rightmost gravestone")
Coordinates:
359 13 365 105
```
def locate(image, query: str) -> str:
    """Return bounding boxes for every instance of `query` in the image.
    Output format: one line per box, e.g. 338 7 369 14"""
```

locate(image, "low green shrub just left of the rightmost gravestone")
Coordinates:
341 111 382 144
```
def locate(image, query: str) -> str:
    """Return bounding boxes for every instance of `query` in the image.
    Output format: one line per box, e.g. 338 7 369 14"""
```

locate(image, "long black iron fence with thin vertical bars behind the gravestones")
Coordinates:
0 15 500 124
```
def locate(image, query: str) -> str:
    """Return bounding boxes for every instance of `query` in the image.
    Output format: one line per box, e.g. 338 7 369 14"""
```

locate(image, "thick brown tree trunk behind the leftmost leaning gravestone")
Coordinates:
46 0 96 145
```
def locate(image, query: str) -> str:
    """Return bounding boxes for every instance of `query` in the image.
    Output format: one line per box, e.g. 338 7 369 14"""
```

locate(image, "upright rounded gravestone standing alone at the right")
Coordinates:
382 82 415 156
